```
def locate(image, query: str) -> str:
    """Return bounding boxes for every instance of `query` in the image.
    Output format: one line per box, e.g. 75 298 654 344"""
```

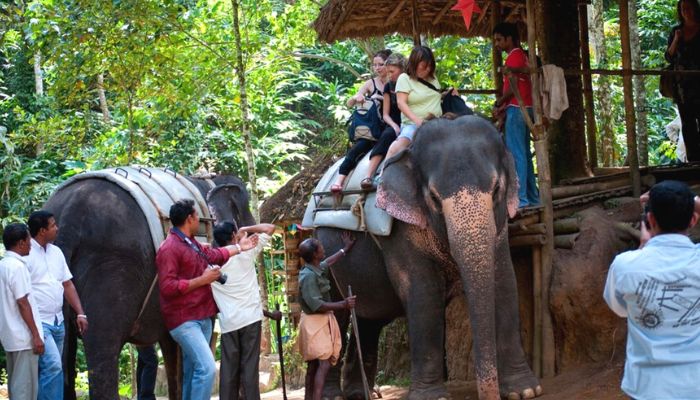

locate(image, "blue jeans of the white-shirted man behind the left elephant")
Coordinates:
38 320 66 400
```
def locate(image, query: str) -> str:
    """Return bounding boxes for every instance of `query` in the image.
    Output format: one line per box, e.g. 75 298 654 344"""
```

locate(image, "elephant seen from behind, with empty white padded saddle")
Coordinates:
44 175 254 399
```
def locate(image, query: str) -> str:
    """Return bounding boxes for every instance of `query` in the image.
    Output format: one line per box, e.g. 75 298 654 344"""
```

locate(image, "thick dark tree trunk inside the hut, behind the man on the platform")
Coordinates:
536 0 590 182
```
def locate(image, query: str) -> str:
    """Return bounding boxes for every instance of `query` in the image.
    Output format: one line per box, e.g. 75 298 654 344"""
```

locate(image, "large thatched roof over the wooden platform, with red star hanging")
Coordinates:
313 0 525 43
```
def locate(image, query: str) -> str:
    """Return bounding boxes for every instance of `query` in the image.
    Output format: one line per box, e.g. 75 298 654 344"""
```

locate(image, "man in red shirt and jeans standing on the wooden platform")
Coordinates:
493 22 540 207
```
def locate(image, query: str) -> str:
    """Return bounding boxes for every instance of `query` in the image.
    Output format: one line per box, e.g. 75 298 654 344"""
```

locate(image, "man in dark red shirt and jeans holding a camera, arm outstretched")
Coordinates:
156 199 258 400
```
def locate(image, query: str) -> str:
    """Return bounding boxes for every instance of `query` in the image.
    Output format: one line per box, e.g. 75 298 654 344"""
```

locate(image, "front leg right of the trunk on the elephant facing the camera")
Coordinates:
496 229 542 399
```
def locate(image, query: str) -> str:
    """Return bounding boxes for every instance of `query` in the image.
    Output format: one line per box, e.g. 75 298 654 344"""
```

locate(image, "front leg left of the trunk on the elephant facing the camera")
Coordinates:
384 247 448 400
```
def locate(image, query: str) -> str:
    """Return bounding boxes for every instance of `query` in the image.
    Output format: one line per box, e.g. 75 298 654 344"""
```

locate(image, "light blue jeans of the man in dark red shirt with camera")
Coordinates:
170 318 216 400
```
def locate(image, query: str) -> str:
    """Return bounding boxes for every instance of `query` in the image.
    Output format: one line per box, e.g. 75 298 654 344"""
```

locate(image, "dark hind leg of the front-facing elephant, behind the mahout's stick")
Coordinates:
343 318 389 400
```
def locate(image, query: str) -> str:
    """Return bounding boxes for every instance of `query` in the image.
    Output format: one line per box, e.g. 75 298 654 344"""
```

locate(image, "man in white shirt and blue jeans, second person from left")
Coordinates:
26 210 88 400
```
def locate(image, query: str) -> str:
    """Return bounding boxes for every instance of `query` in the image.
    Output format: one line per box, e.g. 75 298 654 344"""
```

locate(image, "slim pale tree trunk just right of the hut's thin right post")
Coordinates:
629 0 649 166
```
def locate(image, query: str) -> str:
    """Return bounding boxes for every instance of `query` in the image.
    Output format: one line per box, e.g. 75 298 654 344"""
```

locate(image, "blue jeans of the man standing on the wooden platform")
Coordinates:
506 107 540 207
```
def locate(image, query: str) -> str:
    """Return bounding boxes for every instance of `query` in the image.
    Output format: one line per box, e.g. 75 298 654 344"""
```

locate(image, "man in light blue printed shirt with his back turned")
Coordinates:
603 181 700 400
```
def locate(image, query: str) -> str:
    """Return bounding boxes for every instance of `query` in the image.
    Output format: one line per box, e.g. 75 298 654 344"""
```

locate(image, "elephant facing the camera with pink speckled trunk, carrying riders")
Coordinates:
315 116 542 400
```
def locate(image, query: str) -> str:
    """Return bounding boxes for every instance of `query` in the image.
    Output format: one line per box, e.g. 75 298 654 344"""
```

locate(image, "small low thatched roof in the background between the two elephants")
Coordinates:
260 156 335 223
